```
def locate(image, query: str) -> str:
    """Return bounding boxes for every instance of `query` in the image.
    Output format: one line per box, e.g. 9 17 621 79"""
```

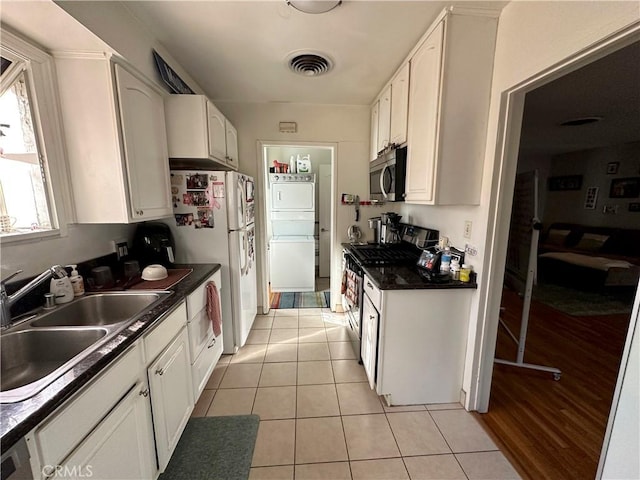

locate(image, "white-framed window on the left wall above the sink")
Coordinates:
0 31 70 244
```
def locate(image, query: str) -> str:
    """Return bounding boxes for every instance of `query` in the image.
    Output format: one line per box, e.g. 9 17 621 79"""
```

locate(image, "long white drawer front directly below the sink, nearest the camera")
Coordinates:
35 343 142 465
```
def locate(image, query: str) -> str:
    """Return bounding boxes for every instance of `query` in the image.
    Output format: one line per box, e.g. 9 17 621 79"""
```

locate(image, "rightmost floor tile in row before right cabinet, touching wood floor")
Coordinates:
430 410 498 453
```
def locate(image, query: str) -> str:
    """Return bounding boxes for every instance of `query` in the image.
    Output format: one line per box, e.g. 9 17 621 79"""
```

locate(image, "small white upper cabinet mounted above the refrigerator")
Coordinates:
164 95 238 170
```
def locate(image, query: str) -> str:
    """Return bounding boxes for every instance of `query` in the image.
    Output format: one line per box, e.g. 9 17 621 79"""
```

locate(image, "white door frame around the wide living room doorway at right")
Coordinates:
467 23 640 473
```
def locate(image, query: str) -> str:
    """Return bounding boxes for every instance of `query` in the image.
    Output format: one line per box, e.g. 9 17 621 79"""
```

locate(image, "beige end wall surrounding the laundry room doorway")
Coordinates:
218 102 369 312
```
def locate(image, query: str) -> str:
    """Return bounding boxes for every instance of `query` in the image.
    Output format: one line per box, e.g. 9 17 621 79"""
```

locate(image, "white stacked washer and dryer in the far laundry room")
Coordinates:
269 173 316 292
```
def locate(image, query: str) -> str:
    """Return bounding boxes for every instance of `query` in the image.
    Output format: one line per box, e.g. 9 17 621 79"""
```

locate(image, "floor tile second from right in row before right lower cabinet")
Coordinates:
387 411 451 457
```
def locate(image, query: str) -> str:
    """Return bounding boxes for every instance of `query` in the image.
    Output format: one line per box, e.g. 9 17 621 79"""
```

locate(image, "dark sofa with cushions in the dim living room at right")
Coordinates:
538 223 640 291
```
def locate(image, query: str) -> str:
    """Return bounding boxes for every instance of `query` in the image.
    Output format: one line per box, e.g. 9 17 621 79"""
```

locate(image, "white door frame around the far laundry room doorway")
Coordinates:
256 140 338 314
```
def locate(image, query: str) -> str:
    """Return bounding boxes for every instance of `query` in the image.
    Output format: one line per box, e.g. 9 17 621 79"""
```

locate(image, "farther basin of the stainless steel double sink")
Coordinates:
31 292 167 327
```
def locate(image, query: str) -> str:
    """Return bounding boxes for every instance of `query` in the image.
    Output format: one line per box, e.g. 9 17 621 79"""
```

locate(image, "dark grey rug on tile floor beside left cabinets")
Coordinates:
159 415 260 480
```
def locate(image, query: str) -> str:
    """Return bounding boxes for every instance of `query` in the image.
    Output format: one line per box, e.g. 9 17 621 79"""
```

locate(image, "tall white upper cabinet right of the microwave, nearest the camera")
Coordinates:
405 11 497 205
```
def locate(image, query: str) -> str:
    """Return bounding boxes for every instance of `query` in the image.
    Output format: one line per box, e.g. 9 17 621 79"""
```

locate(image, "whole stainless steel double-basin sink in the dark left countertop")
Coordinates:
0 291 172 403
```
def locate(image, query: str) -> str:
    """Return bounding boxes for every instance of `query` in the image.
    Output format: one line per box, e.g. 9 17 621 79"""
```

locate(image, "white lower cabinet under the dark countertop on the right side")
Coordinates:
362 276 473 405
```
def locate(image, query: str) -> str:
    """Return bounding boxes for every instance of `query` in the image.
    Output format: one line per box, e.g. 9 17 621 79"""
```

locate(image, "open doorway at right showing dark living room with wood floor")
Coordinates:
479 42 640 478
